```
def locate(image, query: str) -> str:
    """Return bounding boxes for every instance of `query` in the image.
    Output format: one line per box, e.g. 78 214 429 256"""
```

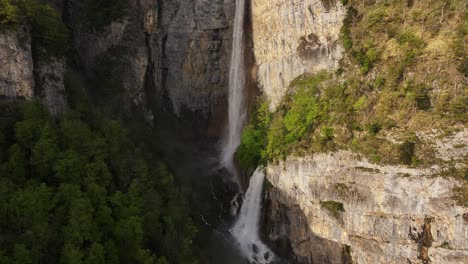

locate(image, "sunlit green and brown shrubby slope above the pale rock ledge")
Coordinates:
239 0 468 172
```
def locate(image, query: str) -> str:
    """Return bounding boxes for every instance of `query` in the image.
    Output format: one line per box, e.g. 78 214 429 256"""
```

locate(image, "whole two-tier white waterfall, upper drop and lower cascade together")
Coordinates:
221 0 274 264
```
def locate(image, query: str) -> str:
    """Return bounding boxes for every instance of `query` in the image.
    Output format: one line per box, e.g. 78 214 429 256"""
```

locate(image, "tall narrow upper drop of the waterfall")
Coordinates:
221 0 245 173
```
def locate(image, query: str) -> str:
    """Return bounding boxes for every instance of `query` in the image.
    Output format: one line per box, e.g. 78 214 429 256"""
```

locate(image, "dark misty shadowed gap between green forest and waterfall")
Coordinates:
155 108 250 264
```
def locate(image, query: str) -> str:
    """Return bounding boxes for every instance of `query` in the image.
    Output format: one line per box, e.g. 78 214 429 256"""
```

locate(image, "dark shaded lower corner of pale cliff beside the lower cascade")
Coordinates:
261 186 353 264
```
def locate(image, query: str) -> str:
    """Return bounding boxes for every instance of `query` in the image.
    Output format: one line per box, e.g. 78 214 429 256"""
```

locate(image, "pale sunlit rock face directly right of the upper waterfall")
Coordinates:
252 0 346 109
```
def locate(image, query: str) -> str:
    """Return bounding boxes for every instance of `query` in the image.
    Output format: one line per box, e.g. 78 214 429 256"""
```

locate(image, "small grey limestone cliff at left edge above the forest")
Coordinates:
0 26 67 115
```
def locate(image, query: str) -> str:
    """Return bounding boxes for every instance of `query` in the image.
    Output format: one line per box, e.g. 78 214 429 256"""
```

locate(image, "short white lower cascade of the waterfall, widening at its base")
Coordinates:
231 167 274 264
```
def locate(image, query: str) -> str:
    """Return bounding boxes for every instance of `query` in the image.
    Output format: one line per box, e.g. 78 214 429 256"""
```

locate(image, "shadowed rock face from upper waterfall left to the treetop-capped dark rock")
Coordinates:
68 0 234 121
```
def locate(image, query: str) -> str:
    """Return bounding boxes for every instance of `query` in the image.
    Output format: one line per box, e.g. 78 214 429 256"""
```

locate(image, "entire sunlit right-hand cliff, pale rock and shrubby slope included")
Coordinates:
252 0 468 264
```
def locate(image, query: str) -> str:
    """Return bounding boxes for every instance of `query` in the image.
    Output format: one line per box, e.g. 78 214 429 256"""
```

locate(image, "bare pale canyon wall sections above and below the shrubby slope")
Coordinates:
251 0 468 264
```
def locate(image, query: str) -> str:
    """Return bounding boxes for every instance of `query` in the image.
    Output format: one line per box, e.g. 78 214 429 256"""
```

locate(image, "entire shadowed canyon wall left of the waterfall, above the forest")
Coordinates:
0 0 235 122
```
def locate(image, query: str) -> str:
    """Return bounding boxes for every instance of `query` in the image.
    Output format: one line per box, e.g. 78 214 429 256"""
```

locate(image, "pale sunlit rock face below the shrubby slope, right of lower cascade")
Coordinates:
266 151 468 264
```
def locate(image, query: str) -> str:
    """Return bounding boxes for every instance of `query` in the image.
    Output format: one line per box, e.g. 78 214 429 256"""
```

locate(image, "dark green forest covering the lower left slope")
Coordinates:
0 102 197 264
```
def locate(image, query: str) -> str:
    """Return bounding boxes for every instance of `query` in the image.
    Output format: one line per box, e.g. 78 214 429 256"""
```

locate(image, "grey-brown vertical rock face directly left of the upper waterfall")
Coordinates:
155 0 235 115
